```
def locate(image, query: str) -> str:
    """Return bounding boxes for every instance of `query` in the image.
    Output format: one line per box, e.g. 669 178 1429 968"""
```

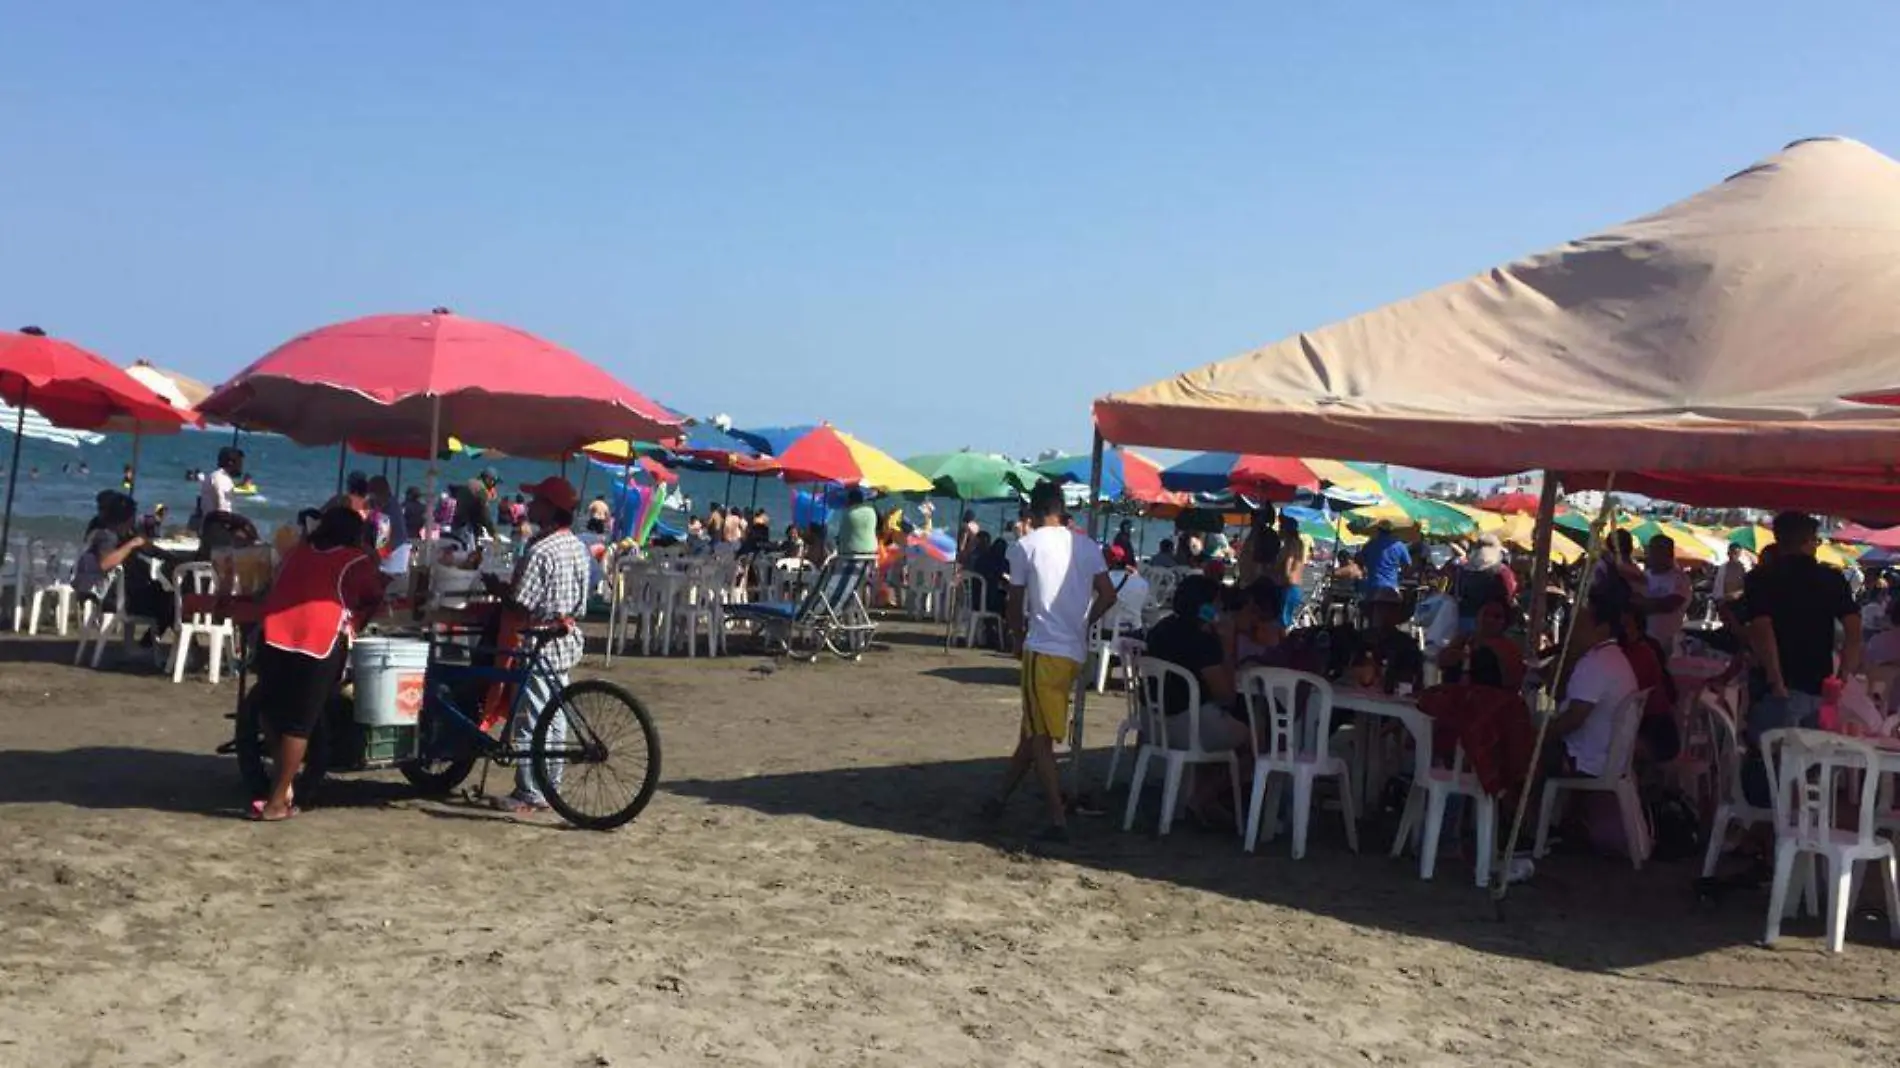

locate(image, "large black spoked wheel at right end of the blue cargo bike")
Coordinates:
528 678 659 830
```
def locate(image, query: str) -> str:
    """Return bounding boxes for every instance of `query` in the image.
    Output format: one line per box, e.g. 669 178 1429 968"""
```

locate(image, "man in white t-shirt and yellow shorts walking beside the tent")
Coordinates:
984 483 1115 842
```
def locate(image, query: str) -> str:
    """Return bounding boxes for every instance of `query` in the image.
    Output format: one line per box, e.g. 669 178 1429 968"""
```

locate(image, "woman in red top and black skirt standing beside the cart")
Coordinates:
251 505 386 821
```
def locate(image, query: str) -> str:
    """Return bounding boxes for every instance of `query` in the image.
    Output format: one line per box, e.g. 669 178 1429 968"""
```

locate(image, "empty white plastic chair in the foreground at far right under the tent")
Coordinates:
1761 730 1900 952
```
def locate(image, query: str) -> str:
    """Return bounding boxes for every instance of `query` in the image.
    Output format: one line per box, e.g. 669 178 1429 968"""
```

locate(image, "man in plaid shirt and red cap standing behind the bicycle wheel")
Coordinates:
496 477 593 813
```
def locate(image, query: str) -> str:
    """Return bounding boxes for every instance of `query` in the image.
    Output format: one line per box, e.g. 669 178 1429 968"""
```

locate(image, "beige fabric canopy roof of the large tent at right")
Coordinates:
1094 139 1900 473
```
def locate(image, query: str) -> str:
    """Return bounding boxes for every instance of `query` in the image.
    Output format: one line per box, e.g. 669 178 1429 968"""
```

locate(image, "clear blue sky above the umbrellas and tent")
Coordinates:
0 0 1900 454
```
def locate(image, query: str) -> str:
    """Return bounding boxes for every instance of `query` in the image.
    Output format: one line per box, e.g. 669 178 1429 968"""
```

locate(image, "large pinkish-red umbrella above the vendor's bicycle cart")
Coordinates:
200 308 682 456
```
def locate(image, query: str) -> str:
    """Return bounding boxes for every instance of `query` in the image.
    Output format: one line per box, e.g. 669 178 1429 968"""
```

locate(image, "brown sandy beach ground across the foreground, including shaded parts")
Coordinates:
0 627 1900 1068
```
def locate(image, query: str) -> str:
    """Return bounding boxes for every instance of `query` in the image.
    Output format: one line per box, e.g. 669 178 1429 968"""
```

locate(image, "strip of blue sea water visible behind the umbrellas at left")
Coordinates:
0 421 1102 545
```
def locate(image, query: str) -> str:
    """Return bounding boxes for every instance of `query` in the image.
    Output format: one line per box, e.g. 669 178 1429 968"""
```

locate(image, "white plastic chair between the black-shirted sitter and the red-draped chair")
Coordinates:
1239 667 1359 861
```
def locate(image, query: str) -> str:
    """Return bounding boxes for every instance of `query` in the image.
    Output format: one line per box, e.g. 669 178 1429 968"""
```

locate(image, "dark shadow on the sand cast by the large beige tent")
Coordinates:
663 753 1887 980
